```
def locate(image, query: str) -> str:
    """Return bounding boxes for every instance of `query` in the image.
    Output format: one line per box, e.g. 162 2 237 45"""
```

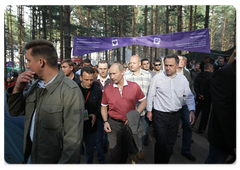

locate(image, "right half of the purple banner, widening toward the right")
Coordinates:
135 28 210 53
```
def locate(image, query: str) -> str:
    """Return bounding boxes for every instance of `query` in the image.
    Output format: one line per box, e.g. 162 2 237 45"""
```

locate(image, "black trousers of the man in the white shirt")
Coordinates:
153 110 180 165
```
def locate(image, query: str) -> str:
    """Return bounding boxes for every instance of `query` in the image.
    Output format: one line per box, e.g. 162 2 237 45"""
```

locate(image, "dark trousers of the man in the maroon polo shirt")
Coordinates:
108 118 132 165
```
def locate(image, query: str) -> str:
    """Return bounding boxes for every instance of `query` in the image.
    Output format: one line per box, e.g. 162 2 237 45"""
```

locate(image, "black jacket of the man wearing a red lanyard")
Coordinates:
80 83 102 133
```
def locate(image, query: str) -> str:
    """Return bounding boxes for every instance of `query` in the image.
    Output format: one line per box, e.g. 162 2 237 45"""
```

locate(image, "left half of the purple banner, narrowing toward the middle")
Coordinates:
73 37 133 56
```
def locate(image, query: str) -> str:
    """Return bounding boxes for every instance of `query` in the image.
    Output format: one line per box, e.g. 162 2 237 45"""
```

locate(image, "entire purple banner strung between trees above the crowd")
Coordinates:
73 28 210 56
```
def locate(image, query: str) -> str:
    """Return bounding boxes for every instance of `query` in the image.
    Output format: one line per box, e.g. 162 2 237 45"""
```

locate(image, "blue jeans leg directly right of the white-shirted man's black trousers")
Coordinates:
180 105 192 154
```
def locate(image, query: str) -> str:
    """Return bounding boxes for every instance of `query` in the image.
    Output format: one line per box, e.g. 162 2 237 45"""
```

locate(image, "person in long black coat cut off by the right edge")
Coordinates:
205 60 237 164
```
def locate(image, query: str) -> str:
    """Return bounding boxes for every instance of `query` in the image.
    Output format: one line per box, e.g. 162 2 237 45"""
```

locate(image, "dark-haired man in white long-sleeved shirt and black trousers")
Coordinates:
147 54 195 164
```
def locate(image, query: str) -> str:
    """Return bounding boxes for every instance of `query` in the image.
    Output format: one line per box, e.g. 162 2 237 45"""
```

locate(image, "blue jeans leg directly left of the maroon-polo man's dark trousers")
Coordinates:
96 119 105 163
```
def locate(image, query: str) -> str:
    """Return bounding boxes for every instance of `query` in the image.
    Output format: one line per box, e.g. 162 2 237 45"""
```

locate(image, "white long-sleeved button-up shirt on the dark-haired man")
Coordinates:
147 71 195 112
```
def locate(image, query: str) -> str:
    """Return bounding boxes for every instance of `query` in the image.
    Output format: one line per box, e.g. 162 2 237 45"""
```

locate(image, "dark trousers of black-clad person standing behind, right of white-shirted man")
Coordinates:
196 98 211 131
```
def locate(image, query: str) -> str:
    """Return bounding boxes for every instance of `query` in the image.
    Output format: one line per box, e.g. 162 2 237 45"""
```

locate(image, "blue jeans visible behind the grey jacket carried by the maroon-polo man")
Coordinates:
129 114 149 155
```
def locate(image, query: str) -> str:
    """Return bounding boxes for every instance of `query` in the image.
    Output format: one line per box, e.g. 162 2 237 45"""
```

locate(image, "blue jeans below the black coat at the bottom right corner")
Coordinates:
204 144 228 165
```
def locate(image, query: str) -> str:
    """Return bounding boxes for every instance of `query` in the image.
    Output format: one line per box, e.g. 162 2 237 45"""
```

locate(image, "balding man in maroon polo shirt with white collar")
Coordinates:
101 63 147 164
